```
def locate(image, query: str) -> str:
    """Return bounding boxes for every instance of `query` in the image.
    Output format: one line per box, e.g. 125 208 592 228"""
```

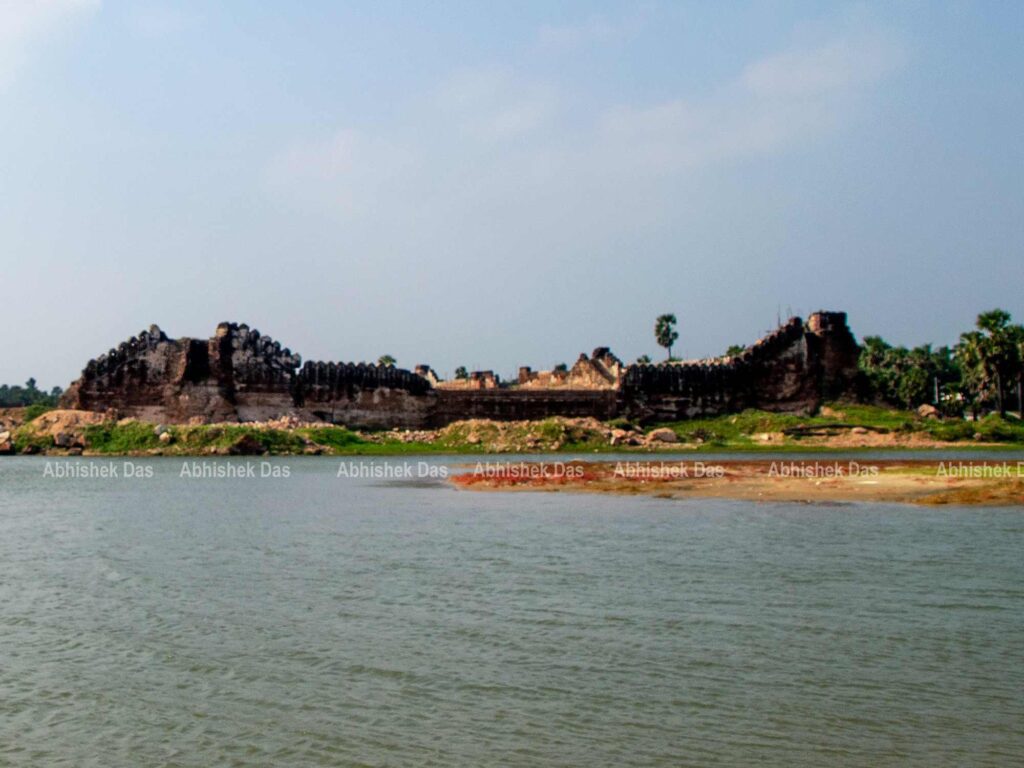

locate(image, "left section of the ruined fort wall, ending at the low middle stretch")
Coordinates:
61 323 430 427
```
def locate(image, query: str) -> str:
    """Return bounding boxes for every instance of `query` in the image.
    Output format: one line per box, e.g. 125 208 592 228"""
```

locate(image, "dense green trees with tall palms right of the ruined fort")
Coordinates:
859 309 1024 417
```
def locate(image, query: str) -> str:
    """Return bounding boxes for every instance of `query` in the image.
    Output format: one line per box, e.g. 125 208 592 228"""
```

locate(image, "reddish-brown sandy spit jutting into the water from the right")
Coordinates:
452 459 1024 505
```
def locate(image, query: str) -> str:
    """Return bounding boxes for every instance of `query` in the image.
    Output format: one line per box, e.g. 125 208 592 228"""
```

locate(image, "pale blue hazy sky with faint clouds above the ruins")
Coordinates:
0 0 1024 388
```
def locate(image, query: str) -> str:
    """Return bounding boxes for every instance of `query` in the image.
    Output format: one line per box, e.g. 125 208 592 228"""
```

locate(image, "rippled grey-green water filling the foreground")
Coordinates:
0 458 1024 768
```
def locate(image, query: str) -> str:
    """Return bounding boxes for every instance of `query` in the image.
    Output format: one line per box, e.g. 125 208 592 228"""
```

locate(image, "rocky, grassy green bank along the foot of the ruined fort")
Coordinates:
10 404 1024 456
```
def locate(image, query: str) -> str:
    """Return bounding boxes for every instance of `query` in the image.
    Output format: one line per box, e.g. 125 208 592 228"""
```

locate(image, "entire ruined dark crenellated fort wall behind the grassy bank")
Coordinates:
61 312 858 428
